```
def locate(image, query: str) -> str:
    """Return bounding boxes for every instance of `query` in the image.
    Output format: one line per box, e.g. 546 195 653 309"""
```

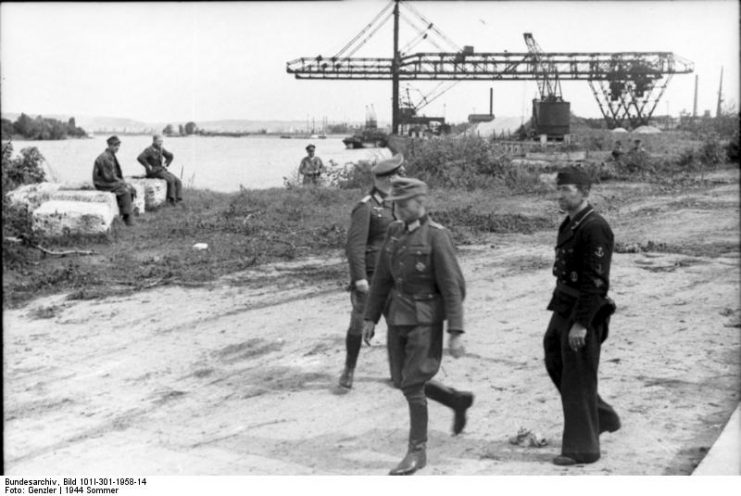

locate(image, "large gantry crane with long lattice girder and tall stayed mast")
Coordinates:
286 0 694 134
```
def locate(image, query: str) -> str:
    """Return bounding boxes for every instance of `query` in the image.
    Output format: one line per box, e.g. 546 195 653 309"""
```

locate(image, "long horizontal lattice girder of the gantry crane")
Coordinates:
286 52 694 80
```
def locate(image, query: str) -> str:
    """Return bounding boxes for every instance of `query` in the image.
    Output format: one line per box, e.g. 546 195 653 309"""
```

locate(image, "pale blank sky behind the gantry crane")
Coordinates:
0 0 739 123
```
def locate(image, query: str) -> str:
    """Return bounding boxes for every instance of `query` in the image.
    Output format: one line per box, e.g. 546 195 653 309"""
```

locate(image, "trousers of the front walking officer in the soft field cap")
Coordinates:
388 323 460 446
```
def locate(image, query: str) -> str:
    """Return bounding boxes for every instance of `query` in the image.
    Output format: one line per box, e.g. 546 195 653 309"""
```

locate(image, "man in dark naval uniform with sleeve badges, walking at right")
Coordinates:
543 168 620 465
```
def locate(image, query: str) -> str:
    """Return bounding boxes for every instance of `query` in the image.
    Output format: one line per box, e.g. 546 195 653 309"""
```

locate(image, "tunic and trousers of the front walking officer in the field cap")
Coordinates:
364 216 466 446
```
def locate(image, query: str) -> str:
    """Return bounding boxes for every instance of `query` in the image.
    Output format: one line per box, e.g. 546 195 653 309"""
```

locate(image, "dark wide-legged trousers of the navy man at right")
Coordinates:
543 312 620 463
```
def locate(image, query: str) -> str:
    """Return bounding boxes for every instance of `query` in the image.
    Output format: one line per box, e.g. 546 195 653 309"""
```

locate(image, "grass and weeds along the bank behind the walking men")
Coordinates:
3 128 736 307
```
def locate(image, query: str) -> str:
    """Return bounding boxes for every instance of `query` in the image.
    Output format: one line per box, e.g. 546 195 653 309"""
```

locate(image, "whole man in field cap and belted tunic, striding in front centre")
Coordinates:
363 178 473 475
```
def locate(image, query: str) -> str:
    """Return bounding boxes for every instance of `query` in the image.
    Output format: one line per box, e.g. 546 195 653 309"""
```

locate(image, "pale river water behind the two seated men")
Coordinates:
8 136 391 193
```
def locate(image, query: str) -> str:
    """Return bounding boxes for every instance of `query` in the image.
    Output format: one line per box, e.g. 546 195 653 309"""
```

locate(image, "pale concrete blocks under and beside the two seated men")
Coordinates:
8 179 167 237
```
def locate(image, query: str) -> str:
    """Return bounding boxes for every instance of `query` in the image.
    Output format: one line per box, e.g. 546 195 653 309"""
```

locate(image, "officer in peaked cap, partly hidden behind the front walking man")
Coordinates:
340 154 404 389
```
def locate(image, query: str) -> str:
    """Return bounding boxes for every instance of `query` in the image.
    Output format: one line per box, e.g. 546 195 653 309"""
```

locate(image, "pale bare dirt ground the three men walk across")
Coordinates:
3 171 741 475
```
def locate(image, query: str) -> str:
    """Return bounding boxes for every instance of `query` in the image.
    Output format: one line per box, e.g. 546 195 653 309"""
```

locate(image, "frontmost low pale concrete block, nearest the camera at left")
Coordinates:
32 201 116 237
